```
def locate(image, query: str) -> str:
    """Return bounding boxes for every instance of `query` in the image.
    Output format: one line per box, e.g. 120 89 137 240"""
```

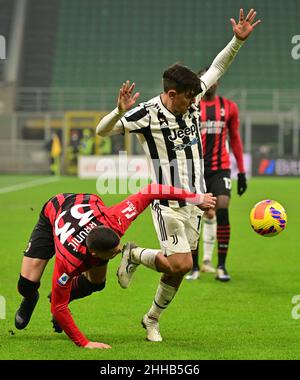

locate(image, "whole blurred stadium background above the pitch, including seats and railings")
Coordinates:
0 0 300 173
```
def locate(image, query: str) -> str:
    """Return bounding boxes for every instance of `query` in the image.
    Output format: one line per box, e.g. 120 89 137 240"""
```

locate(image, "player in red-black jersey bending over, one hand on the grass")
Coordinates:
15 184 215 348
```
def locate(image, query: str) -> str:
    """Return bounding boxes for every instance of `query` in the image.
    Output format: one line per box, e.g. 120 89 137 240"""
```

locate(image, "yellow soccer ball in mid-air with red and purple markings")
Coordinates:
250 199 287 237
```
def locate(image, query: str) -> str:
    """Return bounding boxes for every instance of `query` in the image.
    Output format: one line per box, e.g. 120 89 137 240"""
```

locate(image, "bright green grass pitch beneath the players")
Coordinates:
0 176 300 360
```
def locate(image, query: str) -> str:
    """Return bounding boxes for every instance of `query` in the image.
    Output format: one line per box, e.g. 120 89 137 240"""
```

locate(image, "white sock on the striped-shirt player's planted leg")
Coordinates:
148 281 177 320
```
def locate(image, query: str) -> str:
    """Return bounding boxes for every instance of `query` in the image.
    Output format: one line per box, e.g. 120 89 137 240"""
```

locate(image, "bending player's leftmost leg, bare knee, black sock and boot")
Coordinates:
15 256 49 330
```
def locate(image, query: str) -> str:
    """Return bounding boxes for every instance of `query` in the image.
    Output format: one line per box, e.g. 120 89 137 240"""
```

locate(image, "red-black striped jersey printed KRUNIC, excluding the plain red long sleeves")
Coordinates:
44 193 139 275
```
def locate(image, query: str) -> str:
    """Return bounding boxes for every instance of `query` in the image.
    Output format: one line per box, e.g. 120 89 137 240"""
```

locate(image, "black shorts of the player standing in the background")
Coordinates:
204 170 231 197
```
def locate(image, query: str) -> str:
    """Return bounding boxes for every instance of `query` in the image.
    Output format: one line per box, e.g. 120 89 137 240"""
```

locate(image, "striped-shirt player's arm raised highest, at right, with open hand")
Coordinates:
200 9 261 96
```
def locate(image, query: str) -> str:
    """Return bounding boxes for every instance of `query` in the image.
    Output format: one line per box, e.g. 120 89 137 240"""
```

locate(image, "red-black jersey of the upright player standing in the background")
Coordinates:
199 96 245 173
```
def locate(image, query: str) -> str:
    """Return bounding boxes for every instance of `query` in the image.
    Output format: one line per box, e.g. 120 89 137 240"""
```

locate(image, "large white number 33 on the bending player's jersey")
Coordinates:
54 204 94 244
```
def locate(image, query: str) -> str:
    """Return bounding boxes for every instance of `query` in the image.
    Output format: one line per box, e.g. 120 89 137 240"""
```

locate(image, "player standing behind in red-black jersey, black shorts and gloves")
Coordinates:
186 69 247 281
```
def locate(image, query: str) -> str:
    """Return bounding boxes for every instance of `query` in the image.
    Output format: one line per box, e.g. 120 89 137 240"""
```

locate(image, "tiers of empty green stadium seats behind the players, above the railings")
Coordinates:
12 0 300 109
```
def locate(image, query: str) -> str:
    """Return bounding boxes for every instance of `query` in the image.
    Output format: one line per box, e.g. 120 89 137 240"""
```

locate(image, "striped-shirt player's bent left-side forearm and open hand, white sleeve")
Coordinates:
96 81 140 137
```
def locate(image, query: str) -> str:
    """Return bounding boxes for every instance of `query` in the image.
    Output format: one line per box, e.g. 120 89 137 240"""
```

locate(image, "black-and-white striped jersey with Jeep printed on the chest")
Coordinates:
121 96 206 207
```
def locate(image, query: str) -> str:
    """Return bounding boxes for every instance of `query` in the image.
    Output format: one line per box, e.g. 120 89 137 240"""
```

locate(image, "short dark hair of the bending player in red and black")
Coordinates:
86 226 120 252
